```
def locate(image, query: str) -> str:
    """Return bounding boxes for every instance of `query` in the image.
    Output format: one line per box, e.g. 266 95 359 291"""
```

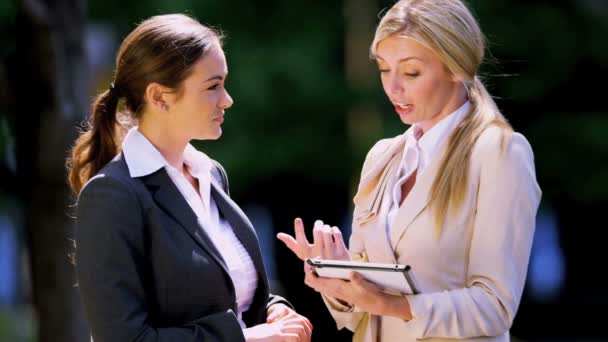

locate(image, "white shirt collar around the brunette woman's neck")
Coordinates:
122 127 212 179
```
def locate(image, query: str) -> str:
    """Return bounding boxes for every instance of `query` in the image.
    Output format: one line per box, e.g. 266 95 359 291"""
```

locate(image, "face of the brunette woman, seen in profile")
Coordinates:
171 45 233 140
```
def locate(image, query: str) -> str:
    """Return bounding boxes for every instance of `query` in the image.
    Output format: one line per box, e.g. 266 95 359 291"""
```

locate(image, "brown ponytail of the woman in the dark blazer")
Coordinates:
67 84 120 194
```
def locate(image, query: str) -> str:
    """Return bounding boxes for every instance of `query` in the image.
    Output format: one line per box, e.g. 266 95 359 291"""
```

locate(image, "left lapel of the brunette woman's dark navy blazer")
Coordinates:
141 168 229 274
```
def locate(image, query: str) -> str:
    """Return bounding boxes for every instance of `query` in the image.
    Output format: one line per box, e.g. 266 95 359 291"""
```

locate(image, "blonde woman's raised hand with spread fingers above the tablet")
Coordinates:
277 217 350 260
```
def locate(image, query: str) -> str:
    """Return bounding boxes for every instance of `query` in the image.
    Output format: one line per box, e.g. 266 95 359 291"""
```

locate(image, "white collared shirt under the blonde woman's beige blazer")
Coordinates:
386 101 471 235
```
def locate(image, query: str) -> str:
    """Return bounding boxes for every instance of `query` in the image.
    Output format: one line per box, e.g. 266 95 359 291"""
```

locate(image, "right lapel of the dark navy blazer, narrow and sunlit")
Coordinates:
211 182 268 286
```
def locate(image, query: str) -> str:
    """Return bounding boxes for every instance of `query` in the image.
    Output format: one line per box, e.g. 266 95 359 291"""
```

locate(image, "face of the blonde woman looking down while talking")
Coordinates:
376 36 466 132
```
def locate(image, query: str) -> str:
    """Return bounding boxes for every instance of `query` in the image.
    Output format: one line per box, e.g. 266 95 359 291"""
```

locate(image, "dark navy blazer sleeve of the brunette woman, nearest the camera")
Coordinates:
76 176 244 342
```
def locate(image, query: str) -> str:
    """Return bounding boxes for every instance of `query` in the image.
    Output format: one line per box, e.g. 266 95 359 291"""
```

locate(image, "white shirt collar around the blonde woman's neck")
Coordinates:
406 101 471 162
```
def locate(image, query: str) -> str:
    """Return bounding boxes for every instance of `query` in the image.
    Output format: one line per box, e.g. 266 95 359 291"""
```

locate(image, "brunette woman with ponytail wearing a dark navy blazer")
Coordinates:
69 14 312 342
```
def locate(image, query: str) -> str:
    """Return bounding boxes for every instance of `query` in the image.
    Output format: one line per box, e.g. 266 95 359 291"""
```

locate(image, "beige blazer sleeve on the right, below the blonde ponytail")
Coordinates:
403 133 541 339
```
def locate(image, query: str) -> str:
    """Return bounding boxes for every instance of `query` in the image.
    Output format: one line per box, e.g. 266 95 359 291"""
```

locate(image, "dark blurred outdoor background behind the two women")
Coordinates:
0 0 608 342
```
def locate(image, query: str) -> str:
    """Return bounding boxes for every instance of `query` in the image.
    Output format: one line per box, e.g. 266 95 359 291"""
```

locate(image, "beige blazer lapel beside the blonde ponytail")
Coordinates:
390 142 445 249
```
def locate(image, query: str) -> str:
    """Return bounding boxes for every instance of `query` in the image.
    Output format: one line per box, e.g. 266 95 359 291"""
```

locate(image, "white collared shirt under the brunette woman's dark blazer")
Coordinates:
122 127 258 328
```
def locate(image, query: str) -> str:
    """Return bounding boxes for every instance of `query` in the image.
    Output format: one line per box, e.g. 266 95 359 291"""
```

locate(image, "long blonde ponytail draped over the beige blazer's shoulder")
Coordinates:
430 76 513 237
